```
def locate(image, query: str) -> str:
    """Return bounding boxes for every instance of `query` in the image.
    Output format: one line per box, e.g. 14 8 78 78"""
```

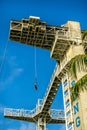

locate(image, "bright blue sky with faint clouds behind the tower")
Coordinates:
0 0 87 130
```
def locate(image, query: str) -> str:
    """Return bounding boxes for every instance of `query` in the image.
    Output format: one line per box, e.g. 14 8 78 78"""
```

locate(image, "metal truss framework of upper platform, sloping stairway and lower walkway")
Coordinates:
4 16 85 130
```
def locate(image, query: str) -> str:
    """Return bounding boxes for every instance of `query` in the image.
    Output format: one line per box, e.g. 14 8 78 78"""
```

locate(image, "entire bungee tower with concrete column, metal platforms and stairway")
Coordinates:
4 16 87 130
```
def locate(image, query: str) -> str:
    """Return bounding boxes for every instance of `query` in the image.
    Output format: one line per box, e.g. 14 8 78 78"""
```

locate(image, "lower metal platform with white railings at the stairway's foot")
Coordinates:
4 103 65 124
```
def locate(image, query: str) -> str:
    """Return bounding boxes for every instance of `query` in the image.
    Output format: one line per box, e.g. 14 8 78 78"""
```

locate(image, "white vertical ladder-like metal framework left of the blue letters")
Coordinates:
62 73 74 130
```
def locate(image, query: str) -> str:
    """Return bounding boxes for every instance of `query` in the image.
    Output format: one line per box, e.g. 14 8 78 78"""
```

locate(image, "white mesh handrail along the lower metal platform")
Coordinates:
4 108 65 120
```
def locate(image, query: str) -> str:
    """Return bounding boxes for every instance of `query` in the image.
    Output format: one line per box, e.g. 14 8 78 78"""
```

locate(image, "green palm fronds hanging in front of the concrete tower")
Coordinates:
69 30 87 102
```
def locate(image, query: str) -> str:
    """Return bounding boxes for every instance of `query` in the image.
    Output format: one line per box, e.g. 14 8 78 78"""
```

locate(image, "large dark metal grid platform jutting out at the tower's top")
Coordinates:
9 17 70 60
